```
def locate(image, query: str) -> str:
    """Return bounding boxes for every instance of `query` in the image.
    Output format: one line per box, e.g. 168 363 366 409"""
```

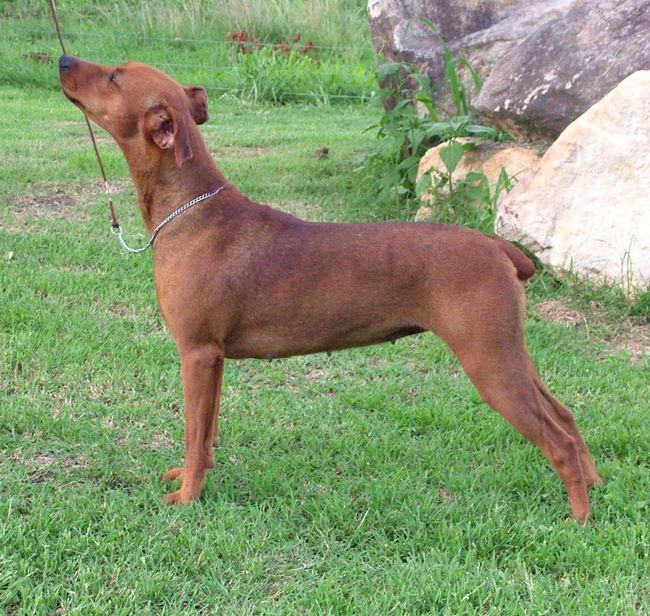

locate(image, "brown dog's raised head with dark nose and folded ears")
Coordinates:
59 55 208 166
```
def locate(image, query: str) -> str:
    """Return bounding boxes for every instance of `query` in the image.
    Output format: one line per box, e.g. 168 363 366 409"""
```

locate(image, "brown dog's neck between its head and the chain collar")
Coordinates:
120 125 227 233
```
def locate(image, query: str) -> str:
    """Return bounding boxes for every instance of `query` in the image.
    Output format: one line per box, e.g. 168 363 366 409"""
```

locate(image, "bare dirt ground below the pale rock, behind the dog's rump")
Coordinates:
535 299 650 363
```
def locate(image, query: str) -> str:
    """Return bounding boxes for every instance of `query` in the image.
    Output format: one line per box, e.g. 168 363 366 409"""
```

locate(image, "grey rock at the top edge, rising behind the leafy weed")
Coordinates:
368 0 578 111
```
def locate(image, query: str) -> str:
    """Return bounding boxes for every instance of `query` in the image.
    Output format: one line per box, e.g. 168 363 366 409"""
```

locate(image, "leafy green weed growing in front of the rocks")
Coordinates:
358 20 510 223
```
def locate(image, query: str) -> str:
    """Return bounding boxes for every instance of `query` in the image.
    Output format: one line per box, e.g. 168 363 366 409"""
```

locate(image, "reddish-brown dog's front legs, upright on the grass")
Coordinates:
163 345 224 504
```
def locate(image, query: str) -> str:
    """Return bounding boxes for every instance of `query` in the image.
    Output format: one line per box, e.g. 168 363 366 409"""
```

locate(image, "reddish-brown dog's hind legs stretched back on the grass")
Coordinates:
434 281 600 522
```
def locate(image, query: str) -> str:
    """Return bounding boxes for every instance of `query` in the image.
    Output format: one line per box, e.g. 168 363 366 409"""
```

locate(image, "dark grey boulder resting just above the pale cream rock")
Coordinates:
474 0 650 141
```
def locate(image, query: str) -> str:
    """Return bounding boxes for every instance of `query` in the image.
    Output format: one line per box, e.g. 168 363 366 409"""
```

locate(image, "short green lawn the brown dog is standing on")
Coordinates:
0 86 650 616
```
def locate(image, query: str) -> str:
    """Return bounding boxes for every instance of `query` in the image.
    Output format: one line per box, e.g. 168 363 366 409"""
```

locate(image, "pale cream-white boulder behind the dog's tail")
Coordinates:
495 71 650 291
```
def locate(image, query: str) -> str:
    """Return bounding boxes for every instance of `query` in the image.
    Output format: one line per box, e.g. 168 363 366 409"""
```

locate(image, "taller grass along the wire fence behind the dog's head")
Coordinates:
0 0 376 103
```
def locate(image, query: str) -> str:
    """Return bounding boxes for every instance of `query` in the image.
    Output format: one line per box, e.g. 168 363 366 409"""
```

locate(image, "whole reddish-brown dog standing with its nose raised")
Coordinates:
59 56 602 521
